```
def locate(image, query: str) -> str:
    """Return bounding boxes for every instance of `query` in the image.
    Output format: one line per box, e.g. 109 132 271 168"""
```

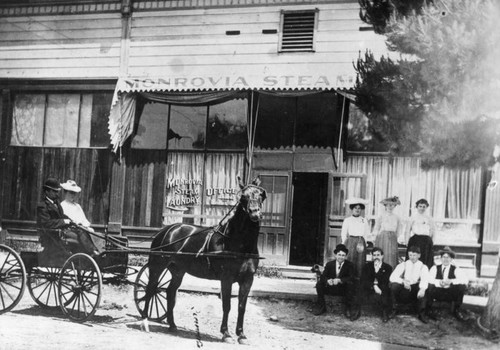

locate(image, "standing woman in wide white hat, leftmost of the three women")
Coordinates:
341 198 370 277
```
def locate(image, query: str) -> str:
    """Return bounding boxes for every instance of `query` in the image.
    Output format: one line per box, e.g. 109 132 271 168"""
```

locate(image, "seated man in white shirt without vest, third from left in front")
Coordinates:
389 246 429 323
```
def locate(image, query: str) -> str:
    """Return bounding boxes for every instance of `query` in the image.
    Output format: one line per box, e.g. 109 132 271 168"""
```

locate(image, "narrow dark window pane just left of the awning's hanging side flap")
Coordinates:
90 92 113 147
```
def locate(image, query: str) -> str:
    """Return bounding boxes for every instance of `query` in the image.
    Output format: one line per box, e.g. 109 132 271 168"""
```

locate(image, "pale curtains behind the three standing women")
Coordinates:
346 157 482 219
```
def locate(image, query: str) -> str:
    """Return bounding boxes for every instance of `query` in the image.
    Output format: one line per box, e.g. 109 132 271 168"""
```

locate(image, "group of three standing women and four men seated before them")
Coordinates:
313 197 468 323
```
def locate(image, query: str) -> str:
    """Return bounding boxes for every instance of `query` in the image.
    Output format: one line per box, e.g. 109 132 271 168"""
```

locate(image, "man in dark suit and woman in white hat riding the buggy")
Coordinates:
37 178 100 257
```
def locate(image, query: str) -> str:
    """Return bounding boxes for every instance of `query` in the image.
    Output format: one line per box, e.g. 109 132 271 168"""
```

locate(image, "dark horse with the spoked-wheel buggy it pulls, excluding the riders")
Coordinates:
0 179 266 342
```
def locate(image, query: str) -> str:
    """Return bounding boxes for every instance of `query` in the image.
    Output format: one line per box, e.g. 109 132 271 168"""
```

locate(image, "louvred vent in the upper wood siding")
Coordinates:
281 11 316 52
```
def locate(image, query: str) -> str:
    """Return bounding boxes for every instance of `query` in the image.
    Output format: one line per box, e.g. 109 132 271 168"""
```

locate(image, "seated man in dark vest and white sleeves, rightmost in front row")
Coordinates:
427 247 469 321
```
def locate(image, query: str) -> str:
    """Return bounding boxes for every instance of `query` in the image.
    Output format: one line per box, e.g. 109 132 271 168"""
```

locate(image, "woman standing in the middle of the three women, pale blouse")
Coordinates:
374 196 403 268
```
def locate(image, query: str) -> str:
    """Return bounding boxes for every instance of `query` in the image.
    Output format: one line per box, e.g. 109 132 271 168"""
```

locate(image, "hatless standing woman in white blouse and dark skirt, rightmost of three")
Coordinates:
406 198 436 268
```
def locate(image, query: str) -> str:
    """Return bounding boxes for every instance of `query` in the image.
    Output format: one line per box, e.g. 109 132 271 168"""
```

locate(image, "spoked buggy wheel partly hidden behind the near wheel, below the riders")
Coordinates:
28 267 60 308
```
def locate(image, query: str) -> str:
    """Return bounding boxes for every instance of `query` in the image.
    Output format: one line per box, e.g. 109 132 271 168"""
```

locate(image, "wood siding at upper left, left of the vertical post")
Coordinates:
0 12 122 78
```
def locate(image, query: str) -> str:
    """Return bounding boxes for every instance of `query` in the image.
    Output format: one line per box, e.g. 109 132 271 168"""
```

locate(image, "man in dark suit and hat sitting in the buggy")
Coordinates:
36 178 98 257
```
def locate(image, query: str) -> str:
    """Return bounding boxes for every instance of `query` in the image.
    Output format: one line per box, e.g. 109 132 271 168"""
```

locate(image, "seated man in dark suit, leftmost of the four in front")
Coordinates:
313 244 360 321
